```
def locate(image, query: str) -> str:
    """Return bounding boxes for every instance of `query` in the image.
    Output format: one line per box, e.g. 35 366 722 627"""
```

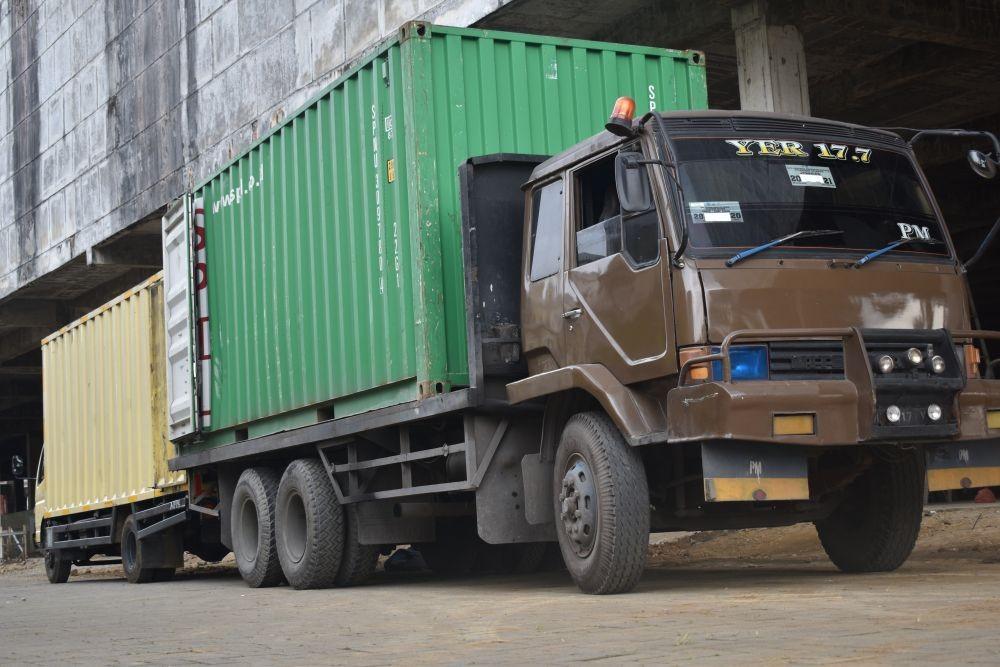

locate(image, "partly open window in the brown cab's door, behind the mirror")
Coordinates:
576 154 660 266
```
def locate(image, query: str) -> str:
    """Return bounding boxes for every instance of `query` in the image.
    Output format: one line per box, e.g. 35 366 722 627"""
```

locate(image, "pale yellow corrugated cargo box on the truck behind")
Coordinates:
42 276 185 516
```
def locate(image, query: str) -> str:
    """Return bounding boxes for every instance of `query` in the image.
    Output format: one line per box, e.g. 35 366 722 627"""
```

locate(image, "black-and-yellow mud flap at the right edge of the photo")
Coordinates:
927 440 1000 491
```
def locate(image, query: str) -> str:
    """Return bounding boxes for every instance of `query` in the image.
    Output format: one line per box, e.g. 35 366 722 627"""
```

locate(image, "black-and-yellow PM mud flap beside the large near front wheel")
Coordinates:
701 443 809 502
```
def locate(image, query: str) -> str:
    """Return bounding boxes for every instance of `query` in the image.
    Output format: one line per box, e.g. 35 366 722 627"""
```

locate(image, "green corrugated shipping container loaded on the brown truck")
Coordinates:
167 23 706 445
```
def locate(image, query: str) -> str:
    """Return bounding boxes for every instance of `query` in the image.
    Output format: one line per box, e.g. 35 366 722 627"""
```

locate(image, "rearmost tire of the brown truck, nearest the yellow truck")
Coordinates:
231 468 281 588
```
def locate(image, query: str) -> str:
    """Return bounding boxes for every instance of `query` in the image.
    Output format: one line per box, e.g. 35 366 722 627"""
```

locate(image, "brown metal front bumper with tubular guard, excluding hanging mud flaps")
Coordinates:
667 328 1000 446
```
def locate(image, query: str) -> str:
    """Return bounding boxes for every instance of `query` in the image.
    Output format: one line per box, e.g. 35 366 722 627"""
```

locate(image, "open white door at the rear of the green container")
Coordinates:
163 196 198 440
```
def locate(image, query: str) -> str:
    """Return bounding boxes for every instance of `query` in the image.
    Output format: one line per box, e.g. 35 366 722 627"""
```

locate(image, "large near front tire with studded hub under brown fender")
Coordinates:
553 412 649 595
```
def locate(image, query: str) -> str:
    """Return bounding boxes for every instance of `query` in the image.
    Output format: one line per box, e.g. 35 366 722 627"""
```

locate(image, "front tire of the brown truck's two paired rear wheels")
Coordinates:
276 459 344 590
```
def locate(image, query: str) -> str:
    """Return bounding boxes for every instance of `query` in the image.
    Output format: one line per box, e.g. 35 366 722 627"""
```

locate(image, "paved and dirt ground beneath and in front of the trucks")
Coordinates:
0 505 1000 664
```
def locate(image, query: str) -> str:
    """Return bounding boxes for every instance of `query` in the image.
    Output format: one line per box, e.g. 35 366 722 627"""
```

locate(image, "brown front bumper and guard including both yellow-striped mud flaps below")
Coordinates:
667 329 1000 500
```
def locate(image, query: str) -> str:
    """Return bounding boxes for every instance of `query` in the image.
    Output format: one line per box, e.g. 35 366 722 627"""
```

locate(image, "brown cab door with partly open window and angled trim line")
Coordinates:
563 148 676 384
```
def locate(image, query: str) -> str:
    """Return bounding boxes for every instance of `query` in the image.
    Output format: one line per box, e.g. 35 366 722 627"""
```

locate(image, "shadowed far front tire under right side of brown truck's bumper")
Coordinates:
816 450 924 572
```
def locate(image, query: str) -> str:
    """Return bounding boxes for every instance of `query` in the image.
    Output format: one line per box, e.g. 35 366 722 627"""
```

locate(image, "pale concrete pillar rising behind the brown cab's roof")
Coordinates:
732 0 809 116
